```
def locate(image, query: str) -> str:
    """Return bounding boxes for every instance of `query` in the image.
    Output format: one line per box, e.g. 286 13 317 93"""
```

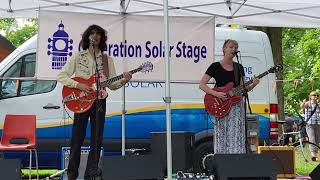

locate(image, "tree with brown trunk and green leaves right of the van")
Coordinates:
251 27 320 119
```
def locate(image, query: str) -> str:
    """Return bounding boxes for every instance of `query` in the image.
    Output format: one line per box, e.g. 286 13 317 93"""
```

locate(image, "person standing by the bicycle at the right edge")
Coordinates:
300 91 320 161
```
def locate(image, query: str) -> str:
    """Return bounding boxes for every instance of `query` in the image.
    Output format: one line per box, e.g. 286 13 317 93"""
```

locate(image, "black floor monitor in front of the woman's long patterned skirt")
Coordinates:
212 154 276 180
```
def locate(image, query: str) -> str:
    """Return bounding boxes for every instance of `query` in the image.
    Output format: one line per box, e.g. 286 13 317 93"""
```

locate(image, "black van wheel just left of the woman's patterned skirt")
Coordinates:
193 141 214 173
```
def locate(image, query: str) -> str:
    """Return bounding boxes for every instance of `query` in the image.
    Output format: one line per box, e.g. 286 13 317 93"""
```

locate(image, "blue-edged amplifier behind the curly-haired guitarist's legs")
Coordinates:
61 146 103 180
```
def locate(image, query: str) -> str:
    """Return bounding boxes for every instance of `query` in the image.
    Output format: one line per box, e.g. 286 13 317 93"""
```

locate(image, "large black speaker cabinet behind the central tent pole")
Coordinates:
151 131 194 173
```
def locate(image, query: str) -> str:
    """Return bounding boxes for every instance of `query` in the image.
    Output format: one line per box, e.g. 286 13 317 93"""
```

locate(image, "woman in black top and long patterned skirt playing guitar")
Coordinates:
199 39 259 154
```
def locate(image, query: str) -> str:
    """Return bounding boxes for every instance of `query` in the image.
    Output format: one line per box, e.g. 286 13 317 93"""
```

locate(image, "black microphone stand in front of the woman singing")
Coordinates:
235 52 251 154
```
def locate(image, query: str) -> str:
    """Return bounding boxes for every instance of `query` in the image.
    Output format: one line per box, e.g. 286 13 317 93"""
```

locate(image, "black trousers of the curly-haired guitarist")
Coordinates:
67 99 106 180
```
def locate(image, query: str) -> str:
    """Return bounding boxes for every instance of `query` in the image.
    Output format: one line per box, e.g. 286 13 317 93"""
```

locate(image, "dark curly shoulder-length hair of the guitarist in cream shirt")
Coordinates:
81 24 107 51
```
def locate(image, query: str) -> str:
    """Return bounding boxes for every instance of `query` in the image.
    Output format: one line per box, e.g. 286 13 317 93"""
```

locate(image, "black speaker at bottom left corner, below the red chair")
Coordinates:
0 159 22 180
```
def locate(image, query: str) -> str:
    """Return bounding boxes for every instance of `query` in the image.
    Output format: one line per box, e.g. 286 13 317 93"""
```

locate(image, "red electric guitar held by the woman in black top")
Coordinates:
204 64 283 118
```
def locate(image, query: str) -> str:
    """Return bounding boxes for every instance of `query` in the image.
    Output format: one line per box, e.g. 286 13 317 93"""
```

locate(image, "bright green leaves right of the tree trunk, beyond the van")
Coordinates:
282 28 320 114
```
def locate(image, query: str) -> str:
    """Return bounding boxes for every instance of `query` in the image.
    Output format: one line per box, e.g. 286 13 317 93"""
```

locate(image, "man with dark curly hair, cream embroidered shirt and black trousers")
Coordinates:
58 25 132 180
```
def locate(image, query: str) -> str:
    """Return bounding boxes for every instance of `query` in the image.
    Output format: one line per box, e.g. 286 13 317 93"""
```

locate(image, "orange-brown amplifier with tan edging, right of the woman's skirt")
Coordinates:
258 146 296 178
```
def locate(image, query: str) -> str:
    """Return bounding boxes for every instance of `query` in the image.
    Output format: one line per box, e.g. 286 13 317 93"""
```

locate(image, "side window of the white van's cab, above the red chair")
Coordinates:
0 53 56 99
